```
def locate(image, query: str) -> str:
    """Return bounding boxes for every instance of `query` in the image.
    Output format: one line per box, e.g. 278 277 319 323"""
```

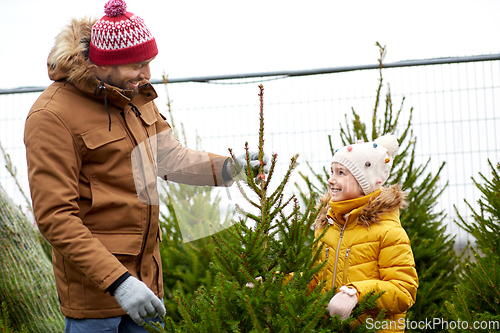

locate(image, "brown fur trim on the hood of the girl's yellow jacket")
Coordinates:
314 185 406 230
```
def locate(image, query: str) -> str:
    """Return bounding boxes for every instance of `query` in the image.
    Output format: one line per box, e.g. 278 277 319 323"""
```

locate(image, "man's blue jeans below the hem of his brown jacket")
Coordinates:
64 315 163 333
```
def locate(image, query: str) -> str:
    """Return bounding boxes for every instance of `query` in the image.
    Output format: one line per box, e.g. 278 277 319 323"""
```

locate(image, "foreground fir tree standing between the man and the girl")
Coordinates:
148 86 380 332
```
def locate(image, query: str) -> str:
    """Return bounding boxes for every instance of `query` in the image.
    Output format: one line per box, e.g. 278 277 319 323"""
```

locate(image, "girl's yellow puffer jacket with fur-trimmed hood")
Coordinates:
310 186 418 332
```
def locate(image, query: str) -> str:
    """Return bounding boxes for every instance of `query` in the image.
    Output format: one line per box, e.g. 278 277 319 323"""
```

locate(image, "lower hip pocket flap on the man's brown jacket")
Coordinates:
93 233 142 256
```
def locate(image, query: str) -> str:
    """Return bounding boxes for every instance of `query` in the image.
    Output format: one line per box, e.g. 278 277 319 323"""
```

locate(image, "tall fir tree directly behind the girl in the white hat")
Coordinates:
297 43 457 332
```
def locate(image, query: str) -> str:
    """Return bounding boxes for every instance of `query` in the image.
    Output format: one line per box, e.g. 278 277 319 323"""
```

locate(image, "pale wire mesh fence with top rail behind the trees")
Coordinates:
0 55 500 248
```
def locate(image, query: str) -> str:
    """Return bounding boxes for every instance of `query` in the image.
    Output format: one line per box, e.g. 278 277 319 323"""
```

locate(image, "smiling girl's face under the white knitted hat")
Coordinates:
328 162 364 202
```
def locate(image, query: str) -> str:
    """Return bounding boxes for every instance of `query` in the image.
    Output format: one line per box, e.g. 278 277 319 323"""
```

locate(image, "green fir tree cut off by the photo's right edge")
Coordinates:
441 161 500 332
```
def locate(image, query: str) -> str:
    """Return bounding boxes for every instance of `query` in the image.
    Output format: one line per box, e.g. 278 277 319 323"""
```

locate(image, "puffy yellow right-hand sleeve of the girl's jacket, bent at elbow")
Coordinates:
347 227 418 315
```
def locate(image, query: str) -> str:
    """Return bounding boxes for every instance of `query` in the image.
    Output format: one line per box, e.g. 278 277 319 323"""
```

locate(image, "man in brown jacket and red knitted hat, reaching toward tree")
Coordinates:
24 0 266 332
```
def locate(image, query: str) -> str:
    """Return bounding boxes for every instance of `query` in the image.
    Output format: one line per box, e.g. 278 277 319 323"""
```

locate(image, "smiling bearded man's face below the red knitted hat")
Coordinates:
95 58 154 95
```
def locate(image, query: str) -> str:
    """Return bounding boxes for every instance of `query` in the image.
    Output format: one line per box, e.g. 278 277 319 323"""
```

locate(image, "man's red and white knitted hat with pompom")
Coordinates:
89 0 158 66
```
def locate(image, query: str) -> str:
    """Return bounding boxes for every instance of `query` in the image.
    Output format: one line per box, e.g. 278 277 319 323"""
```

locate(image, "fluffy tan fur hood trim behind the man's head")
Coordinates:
47 17 97 91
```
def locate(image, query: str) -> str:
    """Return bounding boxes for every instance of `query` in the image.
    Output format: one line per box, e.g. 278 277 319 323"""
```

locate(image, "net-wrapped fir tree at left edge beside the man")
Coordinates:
0 183 64 333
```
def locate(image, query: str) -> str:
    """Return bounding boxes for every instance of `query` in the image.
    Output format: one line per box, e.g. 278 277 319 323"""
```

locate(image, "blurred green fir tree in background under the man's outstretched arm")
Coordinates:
160 183 231 322
